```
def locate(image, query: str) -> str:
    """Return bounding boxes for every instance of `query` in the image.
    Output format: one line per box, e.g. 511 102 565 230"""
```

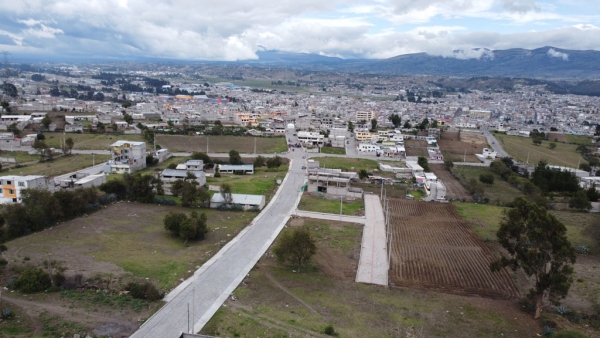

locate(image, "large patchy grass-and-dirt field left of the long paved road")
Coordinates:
0 202 256 337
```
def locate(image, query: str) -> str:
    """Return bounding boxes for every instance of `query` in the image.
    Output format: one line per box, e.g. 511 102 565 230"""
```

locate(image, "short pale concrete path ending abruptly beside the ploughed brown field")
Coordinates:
356 194 388 286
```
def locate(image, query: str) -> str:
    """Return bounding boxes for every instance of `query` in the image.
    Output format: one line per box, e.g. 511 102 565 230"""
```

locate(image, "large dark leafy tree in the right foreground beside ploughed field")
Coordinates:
490 197 577 319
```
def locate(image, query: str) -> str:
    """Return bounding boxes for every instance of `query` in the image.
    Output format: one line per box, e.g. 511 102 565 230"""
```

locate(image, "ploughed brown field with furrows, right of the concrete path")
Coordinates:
390 199 519 298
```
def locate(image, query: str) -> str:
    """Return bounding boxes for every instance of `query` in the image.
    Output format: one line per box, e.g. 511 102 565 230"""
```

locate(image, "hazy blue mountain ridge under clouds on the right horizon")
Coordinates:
247 47 600 79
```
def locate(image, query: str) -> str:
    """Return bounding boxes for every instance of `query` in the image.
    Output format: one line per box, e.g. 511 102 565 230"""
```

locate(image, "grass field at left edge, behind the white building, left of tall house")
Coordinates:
3 154 110 177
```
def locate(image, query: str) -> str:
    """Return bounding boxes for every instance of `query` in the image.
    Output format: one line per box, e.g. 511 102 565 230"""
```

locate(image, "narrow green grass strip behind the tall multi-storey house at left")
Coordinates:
44 133 144 150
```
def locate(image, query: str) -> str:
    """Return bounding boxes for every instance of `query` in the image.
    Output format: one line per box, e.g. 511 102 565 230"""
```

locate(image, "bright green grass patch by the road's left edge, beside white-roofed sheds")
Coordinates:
206 165 288 197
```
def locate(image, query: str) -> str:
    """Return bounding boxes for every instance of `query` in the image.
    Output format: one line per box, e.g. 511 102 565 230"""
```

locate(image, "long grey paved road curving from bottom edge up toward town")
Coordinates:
131 130 305 338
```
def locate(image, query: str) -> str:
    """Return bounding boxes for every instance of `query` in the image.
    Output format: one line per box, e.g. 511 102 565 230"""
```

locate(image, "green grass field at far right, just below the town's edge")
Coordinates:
495 134 585 168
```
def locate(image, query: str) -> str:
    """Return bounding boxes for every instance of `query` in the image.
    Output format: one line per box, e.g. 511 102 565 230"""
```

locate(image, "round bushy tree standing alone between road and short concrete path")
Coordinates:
273 226 317 272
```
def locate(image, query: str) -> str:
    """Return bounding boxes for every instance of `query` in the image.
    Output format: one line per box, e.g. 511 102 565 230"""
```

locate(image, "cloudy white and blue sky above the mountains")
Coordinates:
0 0 600 62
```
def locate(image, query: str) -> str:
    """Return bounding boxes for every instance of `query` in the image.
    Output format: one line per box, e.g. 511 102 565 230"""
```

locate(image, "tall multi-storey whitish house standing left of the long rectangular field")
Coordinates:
104 140 146 174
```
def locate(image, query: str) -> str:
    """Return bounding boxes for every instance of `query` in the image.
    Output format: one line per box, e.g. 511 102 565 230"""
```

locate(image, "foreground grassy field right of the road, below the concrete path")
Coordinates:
201 218 541 338
